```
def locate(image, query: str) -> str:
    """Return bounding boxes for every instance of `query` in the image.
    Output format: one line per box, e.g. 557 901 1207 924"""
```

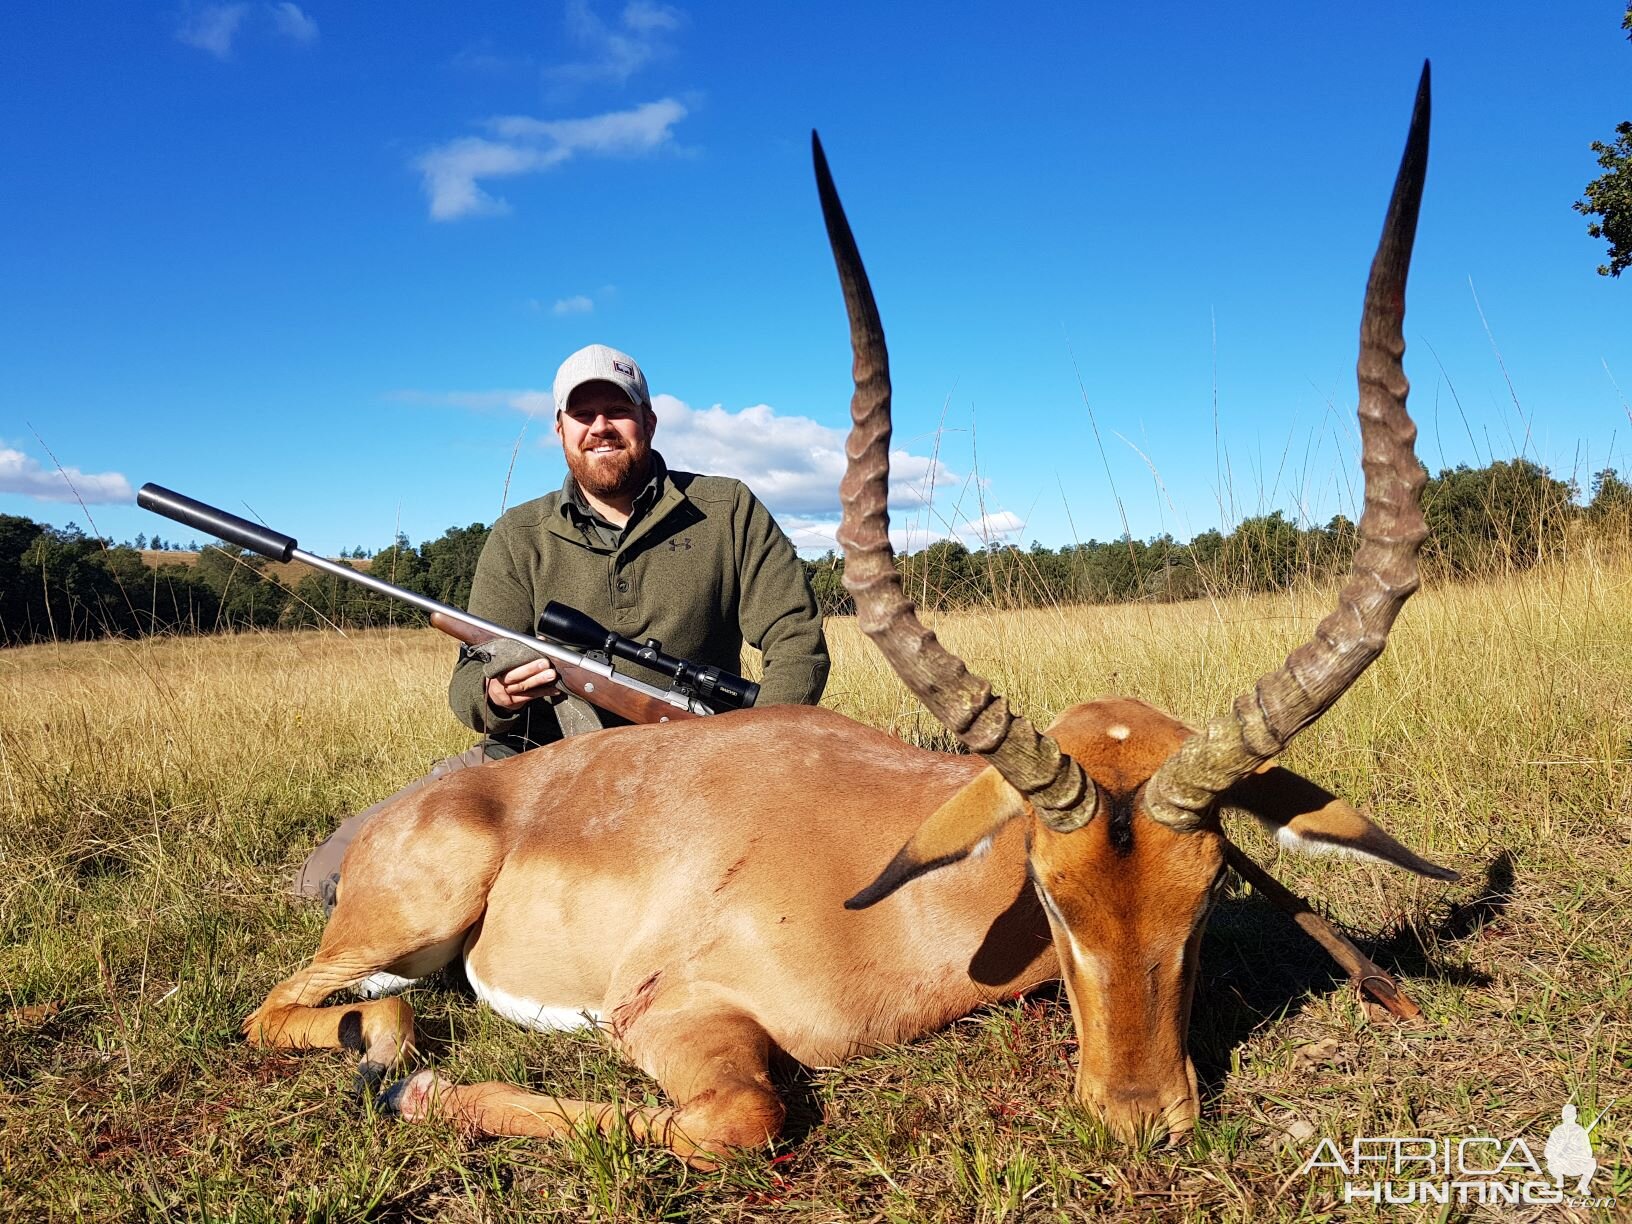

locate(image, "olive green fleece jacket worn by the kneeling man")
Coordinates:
447 455 827 756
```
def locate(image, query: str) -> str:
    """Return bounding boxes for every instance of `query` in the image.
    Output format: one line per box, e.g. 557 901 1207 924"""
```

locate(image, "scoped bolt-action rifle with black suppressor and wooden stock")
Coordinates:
135 485 759 723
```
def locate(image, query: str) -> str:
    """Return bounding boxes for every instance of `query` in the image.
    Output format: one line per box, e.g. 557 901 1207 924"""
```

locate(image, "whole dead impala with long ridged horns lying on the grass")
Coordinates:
245 65 1456 1165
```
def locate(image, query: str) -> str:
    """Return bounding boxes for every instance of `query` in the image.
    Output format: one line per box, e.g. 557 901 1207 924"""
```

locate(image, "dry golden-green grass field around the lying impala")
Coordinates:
0 545 1632 1221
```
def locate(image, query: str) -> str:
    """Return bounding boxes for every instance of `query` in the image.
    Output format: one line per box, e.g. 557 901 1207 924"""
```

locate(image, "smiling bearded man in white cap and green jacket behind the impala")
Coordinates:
295 344 827 904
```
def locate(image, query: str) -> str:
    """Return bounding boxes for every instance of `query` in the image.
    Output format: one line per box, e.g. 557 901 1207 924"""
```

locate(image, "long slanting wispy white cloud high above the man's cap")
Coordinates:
413 98 685 220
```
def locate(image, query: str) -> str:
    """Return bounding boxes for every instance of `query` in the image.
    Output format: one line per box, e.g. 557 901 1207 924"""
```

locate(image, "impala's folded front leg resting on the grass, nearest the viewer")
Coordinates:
388 1009 787 1169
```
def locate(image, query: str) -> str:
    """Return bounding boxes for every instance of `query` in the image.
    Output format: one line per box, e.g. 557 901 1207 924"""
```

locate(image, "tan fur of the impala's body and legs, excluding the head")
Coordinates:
245 707 1058 1162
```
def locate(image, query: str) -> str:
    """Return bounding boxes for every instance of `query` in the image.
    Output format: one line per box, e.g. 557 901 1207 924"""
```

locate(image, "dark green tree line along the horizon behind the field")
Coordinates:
0 459 1632 645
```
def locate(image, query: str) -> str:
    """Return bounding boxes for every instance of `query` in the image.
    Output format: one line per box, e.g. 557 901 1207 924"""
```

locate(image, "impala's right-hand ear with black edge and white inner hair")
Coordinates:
1219 765 1461 880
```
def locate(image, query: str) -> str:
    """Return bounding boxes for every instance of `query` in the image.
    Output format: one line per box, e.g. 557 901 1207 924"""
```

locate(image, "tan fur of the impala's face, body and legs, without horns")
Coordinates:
245 698 1449 1164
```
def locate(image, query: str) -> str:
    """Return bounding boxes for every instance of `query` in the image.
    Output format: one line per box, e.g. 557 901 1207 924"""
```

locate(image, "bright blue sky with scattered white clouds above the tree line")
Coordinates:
0 0 1632 552
